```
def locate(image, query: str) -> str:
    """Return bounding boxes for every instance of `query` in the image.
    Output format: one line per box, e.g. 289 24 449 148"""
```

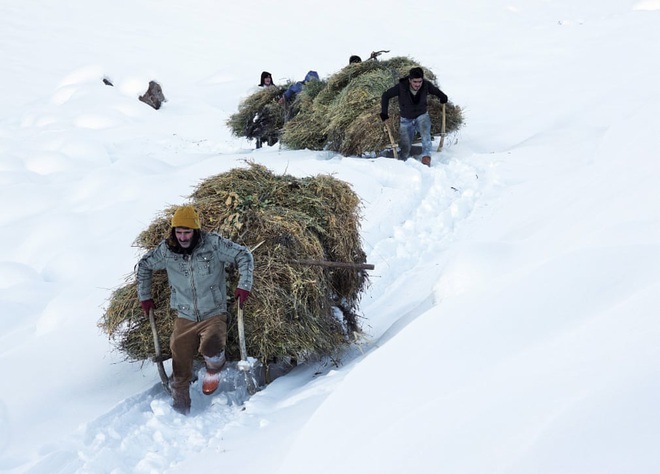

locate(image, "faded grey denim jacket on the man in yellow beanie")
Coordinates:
137 232 254 321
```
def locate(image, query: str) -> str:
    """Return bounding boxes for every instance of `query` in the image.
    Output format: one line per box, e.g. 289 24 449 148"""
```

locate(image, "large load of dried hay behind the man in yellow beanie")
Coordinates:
99 163 368 361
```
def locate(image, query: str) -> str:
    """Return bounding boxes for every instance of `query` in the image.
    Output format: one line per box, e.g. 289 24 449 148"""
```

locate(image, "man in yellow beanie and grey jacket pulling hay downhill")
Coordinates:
137 206 254 414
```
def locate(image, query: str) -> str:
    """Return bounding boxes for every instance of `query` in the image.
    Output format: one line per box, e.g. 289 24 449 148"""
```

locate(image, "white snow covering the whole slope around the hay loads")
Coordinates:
0 0 660 474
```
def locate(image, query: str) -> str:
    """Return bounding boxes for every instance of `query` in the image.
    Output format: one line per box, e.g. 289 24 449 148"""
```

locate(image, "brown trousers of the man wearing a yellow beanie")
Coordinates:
170 314 227 391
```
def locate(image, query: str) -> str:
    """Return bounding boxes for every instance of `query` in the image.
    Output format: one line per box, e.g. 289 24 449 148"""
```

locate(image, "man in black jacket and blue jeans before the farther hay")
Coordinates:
380 67 449 166
